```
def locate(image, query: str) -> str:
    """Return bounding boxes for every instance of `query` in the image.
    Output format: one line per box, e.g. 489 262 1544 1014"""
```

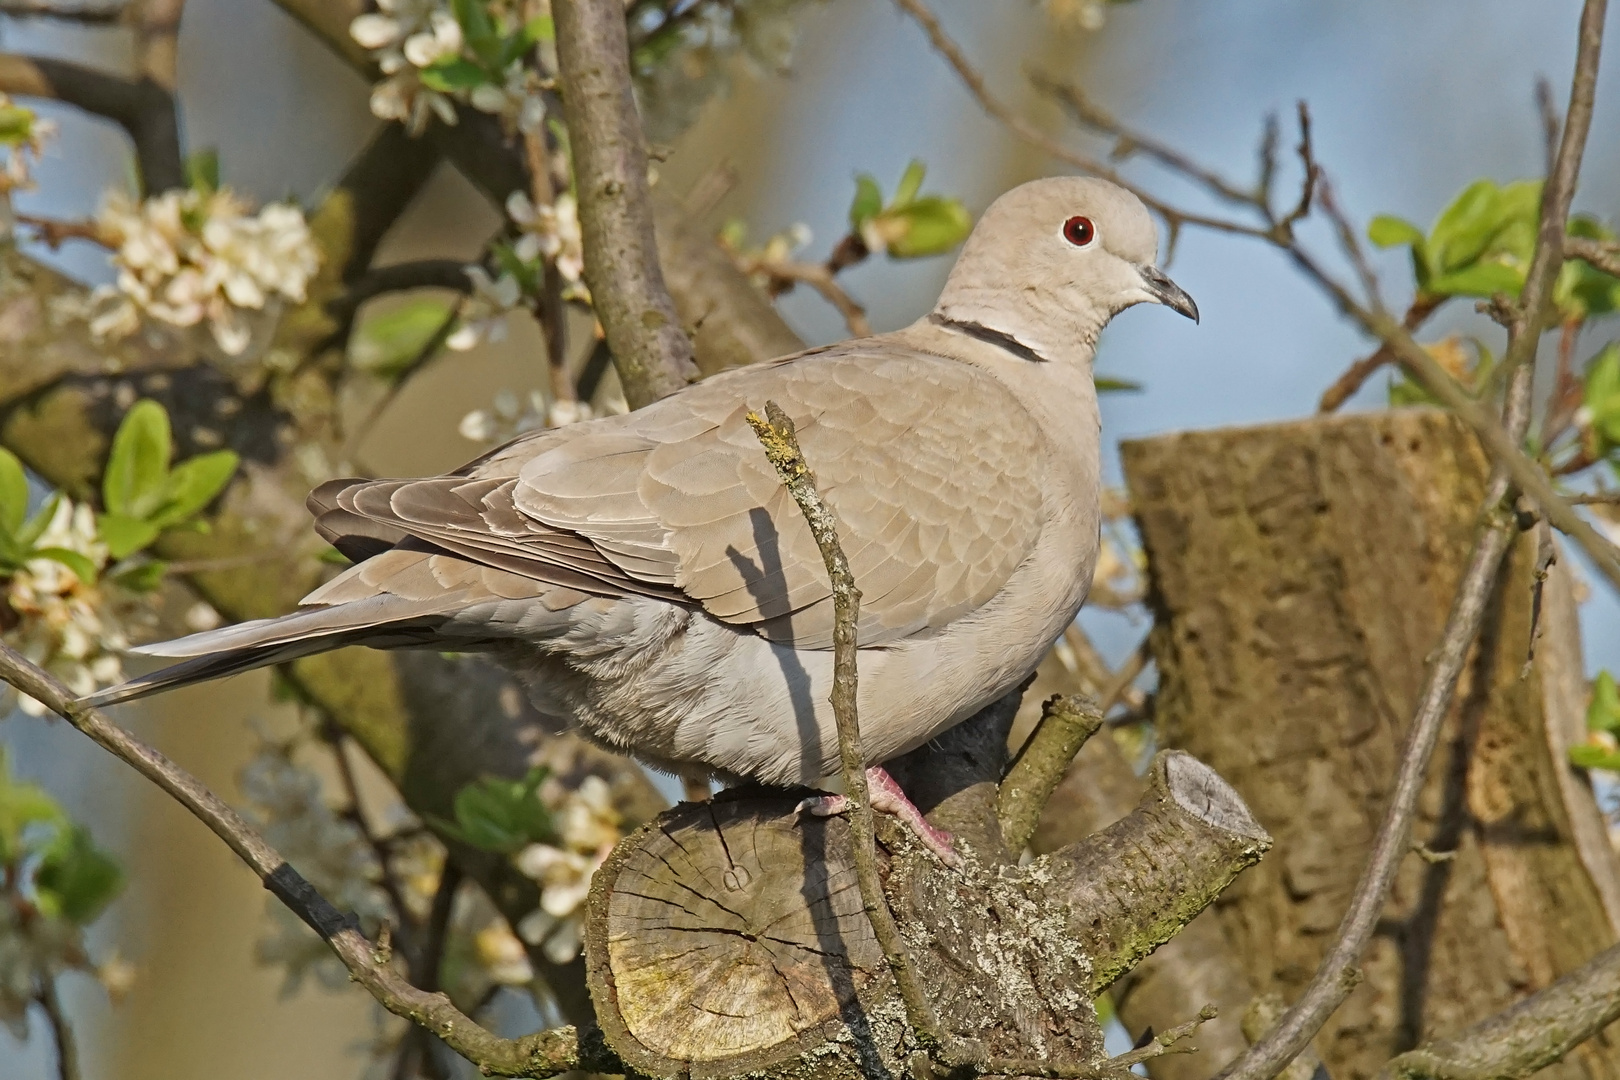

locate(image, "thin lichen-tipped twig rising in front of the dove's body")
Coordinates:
748 402 941 1048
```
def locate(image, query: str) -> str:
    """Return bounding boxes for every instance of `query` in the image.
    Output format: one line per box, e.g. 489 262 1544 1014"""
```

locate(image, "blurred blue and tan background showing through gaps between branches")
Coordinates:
0 0 1620 1080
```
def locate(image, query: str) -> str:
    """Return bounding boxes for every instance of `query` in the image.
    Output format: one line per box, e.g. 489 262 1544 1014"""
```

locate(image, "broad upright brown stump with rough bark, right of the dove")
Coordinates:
1124 410 1620 1080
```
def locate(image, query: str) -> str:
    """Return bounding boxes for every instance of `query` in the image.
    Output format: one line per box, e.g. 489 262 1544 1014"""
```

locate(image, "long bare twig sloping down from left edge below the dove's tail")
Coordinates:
0 643 624 1077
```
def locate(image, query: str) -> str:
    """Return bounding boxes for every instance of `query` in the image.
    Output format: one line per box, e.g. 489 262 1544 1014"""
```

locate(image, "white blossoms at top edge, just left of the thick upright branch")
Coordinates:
348 0 548 134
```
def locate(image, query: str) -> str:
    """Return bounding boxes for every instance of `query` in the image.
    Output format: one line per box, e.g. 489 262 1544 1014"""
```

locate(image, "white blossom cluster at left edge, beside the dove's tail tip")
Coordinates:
5 497 140 716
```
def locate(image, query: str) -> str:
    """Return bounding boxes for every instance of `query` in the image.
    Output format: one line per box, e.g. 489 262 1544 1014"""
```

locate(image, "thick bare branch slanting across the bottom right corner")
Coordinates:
1379 946 1620 1080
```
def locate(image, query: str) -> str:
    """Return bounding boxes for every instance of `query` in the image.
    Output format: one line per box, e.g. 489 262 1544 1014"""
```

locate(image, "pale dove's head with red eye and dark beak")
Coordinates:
935 176 1199 359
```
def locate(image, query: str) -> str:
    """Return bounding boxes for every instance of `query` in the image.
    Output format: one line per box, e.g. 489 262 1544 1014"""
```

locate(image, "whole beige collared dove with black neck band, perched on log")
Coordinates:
91 178 1197 858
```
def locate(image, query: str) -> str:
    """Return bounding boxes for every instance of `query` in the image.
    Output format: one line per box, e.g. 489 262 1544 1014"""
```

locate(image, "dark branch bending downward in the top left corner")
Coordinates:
0 53 186 193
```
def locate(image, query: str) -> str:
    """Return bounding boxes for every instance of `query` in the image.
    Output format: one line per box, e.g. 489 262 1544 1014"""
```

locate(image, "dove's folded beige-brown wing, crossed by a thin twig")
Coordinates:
322 343 1043 648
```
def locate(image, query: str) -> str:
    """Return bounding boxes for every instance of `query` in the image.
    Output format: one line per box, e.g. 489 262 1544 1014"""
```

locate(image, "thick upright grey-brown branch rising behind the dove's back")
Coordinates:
552 0 698 408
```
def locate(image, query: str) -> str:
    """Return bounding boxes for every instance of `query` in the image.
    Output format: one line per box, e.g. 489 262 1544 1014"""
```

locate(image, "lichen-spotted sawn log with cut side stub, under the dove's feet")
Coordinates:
585 725 1270 1080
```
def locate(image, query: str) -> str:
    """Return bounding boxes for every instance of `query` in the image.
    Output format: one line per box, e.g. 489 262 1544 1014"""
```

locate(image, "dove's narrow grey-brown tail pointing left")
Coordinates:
83 594 444 708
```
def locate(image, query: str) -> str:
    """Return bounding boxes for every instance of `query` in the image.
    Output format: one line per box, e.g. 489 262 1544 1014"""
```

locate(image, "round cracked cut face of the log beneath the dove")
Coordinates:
585 790 886 1077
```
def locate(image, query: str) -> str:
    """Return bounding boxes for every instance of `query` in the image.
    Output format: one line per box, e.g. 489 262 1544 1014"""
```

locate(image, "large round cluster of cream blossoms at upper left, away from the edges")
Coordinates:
91 188 321 356
